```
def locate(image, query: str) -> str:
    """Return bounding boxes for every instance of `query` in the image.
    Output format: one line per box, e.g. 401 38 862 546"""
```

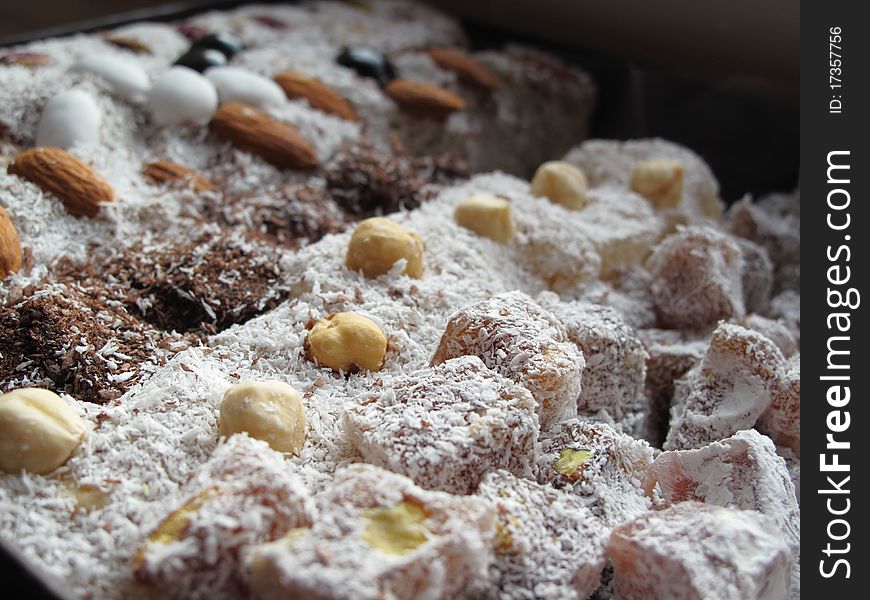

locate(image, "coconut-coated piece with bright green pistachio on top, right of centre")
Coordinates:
538 419 653 527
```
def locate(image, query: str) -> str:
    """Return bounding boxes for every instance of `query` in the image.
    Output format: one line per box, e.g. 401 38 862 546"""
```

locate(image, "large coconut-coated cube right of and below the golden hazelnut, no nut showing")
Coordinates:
344 356 539 494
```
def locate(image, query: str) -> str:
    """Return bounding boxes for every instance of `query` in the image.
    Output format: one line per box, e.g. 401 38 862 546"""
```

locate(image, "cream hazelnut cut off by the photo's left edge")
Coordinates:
0 388 85 475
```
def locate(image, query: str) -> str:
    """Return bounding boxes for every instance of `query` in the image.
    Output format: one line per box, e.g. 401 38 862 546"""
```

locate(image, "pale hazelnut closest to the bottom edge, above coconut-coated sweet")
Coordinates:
220 380 305 454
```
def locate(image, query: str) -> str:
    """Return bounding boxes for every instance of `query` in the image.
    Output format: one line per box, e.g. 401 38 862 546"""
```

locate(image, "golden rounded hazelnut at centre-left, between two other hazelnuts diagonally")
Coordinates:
305 313 387 373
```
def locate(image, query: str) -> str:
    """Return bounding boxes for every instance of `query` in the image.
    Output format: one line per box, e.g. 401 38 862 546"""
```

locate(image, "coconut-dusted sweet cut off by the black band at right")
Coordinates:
758 354 801 458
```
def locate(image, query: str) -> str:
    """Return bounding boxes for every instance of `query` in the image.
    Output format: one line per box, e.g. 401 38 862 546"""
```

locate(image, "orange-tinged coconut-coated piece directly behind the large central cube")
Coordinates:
431 292 584 430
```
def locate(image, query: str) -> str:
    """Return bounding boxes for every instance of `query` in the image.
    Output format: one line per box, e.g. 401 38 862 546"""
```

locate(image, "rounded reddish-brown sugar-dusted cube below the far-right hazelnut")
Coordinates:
648 227 745 329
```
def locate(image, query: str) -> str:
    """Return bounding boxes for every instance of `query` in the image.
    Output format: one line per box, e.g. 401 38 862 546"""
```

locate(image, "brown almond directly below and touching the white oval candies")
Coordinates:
211 102 317 169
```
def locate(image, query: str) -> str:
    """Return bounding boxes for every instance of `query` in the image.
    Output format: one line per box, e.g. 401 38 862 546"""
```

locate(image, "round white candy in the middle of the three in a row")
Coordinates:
148 67 217 125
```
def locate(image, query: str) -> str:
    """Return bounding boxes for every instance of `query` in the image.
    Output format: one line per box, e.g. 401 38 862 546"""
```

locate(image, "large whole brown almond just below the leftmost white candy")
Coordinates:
7 148 115 217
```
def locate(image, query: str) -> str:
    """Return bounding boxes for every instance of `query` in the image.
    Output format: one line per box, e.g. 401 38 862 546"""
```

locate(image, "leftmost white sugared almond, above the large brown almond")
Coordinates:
36 90 103 148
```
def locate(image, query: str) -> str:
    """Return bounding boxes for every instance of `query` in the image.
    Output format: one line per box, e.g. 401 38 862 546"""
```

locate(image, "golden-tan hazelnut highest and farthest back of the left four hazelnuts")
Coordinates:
345 217 423 279
